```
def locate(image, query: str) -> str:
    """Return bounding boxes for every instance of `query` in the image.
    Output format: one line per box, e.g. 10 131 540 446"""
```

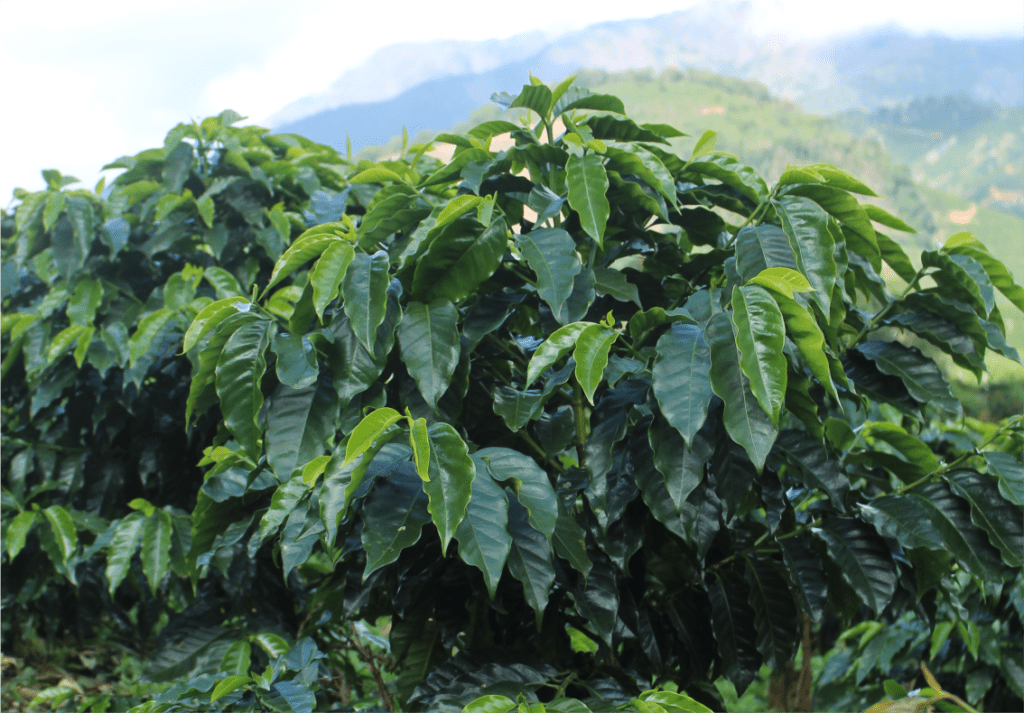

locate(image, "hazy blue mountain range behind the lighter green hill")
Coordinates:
265 0 1024 150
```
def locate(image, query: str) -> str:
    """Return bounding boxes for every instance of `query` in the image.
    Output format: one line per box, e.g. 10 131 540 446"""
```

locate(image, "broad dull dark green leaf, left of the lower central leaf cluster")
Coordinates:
266 384 338 483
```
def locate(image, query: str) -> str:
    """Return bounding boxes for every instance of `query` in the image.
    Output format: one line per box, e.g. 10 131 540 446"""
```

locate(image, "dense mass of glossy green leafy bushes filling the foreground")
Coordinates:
0 81 1024 712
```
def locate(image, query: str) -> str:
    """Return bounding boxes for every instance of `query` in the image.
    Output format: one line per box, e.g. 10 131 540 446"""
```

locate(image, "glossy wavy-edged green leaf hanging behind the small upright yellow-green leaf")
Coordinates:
423 423 476 555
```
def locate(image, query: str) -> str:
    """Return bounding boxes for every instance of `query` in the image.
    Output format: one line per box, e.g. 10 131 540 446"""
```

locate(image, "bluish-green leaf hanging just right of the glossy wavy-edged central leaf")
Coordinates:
455 470 512 599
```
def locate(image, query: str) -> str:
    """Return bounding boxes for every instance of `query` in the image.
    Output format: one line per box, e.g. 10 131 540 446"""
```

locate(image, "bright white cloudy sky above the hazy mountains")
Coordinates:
0 0 1024 206
